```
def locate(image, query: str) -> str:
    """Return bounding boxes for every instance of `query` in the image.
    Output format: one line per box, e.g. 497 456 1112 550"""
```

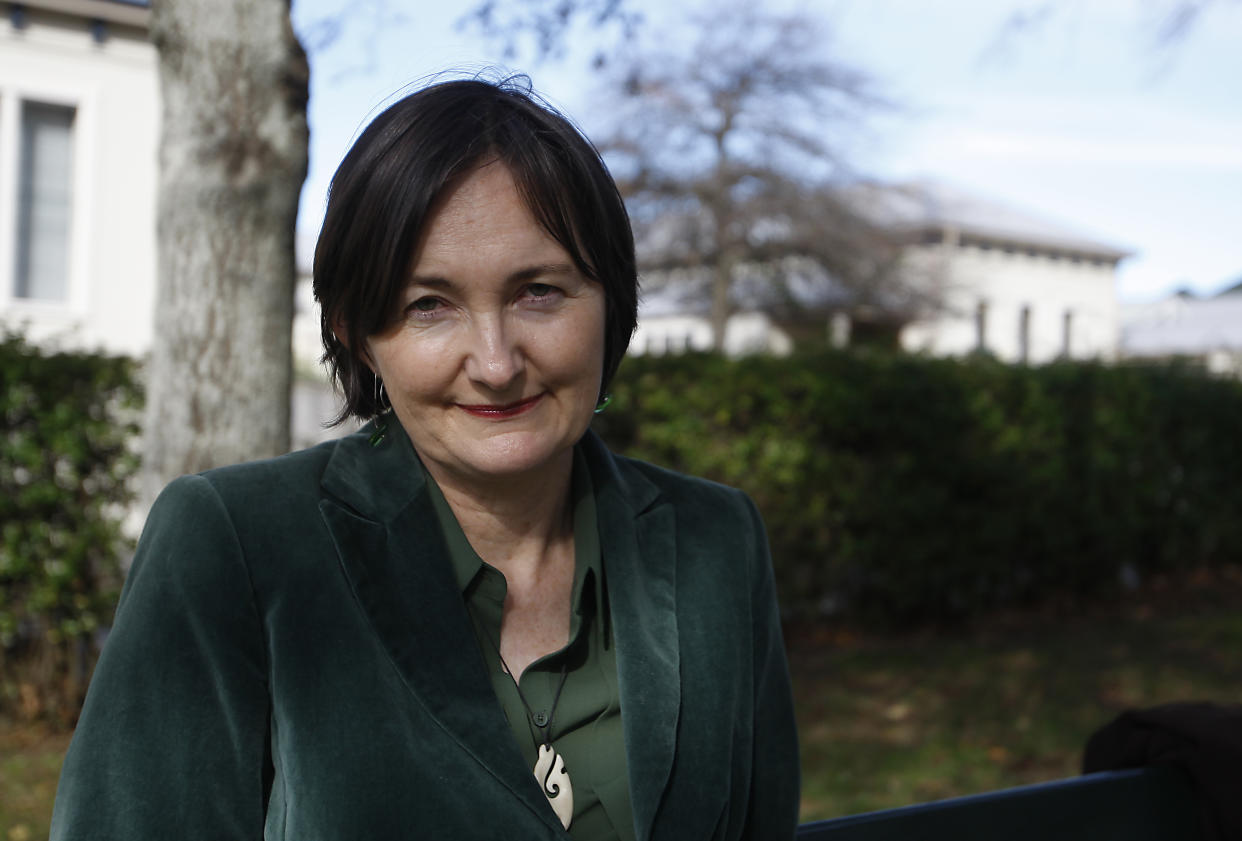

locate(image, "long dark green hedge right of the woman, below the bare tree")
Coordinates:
596 352 1242 625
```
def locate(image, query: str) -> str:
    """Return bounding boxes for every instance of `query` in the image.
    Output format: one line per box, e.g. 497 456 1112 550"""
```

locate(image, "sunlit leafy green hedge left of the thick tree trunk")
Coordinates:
0 334 142 721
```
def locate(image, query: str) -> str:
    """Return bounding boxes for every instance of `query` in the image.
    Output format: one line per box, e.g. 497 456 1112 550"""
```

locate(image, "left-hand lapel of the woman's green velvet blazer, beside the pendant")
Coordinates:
319 417 563 834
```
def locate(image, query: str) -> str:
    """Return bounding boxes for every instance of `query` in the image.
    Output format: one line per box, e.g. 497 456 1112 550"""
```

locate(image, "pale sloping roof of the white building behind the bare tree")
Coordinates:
867 183 1133 261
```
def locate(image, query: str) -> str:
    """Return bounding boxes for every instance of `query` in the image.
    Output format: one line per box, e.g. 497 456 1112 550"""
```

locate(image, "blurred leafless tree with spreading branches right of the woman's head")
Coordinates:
601 6 905 349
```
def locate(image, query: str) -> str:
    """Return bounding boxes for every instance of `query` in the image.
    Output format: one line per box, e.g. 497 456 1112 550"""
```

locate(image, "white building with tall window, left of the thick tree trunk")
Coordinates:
0 0 159 354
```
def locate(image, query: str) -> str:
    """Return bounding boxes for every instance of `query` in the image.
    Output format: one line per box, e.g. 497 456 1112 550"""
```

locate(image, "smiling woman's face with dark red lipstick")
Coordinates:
366 163 605 483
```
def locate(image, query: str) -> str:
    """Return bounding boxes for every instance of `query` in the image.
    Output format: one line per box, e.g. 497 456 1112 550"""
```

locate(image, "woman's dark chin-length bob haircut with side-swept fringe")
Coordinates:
314 77 638 422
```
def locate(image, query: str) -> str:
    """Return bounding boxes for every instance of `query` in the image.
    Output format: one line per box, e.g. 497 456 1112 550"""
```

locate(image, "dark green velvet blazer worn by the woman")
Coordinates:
51 422 799 841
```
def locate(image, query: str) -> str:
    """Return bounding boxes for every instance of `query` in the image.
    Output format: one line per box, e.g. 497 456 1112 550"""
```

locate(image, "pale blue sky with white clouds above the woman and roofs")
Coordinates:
293 0 1242 301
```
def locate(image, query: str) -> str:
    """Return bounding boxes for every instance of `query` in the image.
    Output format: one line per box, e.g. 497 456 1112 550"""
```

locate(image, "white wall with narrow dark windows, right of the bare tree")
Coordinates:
902 241 1119 363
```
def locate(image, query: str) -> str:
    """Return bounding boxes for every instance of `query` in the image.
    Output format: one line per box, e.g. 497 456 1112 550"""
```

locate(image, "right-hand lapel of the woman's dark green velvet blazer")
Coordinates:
582 432 681 841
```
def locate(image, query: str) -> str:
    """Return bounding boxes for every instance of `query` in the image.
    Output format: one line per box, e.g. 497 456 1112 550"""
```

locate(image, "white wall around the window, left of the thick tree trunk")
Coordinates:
0 4 159 354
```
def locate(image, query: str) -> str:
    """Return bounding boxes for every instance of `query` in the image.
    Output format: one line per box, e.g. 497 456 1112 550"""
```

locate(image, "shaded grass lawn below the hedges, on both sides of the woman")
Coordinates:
0 579 1242 841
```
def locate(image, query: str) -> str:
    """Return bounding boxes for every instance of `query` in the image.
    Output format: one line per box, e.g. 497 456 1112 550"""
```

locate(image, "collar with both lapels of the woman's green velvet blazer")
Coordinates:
319 415 681 841
